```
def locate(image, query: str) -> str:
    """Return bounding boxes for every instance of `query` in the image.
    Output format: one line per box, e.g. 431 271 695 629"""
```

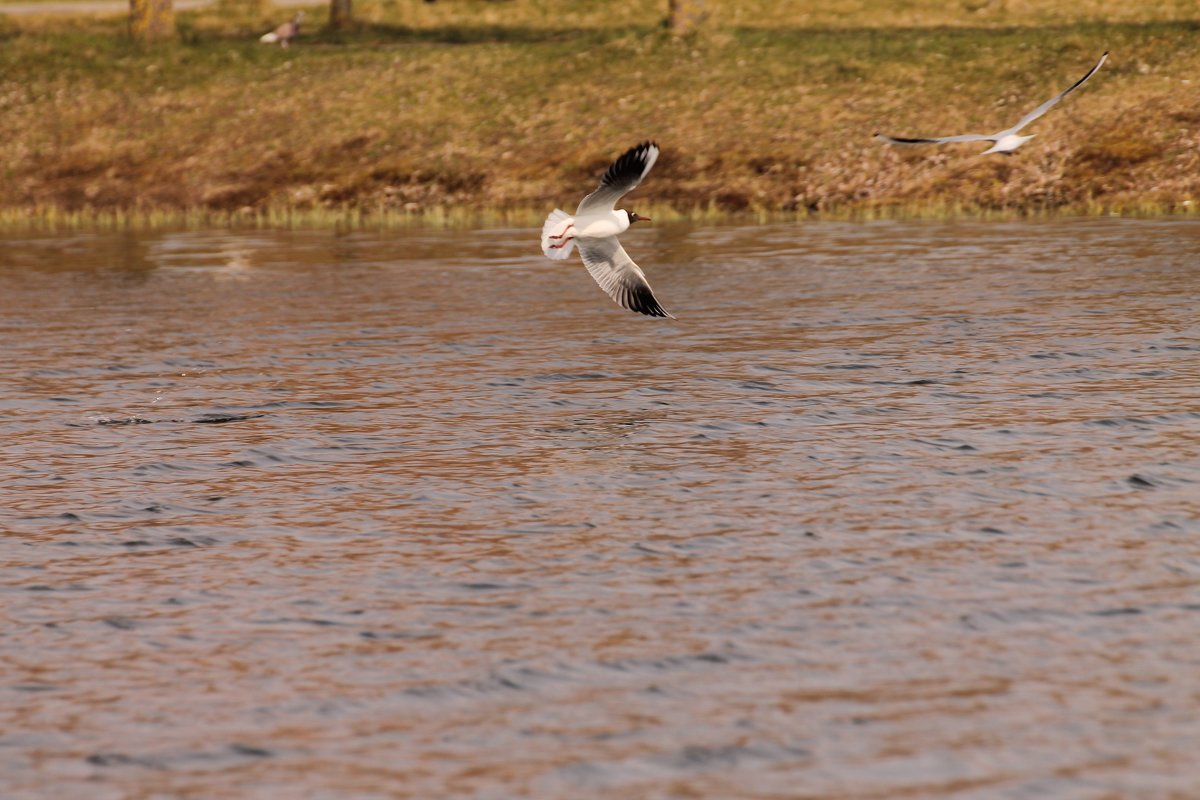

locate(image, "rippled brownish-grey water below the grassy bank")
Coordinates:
0 219 1200 800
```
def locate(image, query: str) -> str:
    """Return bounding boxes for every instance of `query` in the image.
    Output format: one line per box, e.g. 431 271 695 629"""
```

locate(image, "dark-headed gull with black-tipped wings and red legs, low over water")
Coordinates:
541 142 674 319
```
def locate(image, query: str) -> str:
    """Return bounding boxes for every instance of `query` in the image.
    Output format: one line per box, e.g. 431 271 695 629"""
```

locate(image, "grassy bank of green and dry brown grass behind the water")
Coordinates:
0 0 1200 223
